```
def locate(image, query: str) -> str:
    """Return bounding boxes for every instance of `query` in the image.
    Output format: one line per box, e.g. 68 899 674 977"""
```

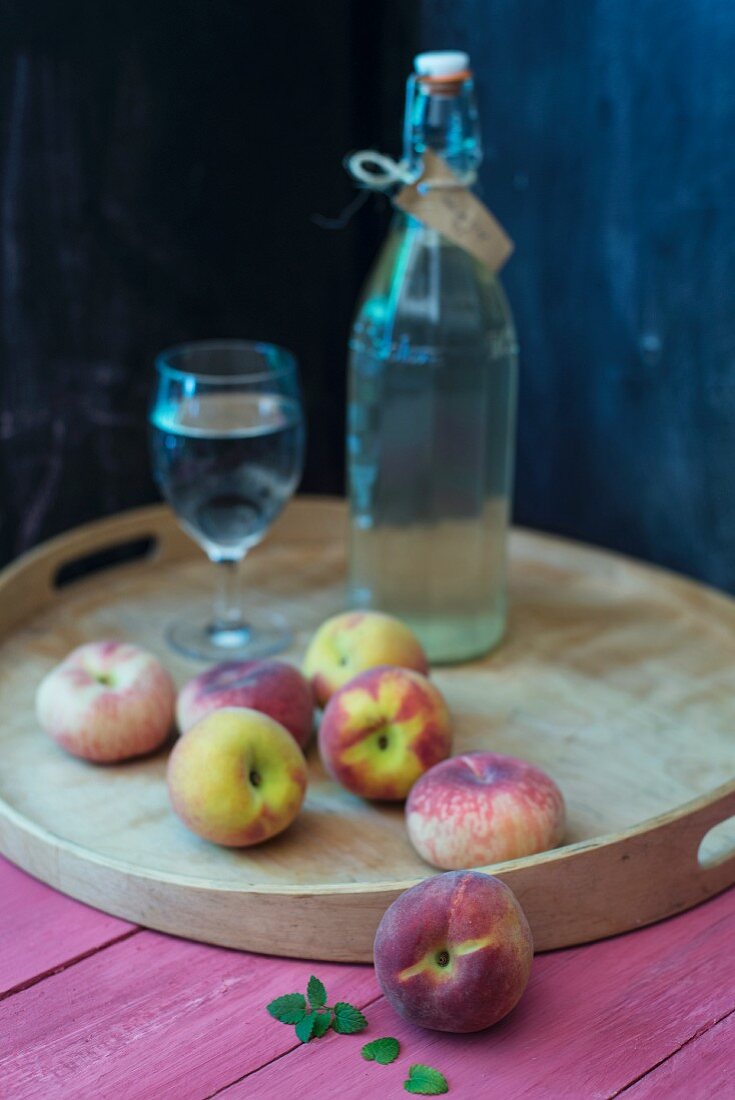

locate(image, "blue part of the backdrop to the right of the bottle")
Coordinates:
423 0 735 591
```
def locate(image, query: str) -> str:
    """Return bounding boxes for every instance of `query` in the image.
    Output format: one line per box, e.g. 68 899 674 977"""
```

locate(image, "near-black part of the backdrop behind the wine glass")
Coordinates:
0 0 416 561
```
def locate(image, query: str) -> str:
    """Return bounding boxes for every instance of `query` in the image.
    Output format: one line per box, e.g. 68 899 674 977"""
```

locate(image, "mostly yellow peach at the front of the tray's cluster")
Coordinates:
166 706 307 848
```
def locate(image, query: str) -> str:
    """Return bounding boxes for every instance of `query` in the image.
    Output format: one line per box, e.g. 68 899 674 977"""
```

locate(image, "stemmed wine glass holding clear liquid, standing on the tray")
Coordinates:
150 340 305 661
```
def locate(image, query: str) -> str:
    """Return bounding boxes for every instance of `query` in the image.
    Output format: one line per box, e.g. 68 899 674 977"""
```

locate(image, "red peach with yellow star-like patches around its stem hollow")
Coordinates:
319 667 452 801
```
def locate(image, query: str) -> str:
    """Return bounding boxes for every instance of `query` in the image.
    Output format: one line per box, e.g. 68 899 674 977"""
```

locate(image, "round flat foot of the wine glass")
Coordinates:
166 612 293 661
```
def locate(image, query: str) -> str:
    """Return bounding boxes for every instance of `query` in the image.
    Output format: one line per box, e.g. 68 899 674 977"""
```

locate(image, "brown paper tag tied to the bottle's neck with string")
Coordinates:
393 150 513 272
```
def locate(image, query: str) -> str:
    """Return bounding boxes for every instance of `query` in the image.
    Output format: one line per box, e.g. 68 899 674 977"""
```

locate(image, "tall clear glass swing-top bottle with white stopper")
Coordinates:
348 53 517 662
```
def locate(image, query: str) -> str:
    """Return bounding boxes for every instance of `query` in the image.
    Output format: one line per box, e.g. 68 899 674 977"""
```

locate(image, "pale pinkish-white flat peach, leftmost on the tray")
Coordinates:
36 641 176 763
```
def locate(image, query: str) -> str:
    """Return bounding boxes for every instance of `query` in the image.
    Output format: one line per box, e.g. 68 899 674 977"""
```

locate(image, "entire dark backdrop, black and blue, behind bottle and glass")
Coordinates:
0 0 735 591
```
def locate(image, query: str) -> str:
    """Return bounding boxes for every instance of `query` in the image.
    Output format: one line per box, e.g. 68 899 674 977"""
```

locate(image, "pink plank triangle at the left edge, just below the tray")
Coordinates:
0 857 135 997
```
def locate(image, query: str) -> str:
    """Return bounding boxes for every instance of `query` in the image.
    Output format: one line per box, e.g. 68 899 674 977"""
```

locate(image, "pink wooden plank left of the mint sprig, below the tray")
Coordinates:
0 932 380 1100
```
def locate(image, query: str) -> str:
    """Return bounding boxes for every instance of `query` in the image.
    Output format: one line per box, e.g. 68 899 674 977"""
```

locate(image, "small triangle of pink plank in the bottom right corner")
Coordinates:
621 1011 735 1100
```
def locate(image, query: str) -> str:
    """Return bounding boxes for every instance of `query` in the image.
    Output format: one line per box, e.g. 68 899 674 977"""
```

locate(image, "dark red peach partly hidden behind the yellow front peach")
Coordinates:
176 661 314 748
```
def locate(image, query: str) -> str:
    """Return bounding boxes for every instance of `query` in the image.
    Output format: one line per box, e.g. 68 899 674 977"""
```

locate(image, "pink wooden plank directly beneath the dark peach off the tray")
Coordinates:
224 891 735 1100
